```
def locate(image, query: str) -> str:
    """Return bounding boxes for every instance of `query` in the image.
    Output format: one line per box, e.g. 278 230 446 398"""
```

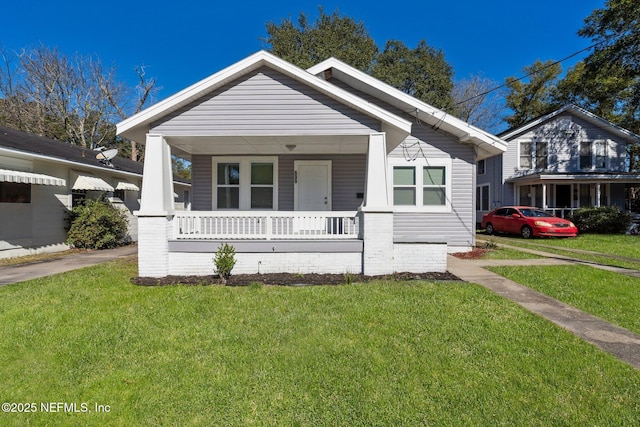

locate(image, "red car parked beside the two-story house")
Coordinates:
482 206 578 239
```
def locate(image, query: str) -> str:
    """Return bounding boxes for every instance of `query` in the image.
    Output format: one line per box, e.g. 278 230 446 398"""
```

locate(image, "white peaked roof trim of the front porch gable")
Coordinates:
117 51 411 143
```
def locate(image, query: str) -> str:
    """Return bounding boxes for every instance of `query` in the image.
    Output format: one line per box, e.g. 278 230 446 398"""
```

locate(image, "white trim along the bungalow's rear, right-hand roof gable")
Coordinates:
307 58 507 152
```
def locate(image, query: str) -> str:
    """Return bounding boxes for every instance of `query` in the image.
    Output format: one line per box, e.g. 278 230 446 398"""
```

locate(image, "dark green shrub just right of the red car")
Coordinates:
569 206 631 234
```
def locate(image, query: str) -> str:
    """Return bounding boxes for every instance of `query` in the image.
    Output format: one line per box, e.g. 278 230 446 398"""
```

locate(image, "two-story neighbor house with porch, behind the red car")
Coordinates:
476 105 640 221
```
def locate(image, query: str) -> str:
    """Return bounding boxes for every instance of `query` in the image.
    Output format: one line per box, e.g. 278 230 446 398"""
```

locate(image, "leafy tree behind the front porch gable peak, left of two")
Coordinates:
264 7 378 71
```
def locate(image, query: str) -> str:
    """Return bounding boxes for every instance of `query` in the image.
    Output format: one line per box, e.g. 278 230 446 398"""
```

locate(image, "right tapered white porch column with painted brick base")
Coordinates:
360 133 394 275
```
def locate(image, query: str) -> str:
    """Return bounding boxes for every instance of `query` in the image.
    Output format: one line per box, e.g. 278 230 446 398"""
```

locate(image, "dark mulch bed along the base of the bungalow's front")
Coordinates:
131 272 460 286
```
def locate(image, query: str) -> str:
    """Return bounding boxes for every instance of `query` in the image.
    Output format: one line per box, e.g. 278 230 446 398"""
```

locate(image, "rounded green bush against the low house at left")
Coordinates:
67 199 128 249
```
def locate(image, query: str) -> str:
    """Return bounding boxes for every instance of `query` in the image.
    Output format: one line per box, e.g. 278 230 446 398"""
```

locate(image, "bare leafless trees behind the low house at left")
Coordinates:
0 45 156 159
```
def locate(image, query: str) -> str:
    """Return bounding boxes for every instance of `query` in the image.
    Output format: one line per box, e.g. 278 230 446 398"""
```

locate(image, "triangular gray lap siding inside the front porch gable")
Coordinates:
152 67 380 136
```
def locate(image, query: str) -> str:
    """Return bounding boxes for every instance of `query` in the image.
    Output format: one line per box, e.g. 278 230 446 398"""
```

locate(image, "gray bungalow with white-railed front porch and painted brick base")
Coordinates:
118 51 506 277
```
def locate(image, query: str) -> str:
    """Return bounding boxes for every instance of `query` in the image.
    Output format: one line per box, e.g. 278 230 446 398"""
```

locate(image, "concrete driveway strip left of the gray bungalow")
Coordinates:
0 245 138 286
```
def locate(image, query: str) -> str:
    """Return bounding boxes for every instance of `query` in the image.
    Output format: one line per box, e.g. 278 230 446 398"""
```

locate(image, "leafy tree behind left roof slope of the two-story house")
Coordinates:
505 60 562 127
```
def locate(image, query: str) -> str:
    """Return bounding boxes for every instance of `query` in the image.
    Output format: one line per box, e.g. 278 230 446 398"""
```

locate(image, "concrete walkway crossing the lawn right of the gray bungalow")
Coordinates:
447 254 640 369
